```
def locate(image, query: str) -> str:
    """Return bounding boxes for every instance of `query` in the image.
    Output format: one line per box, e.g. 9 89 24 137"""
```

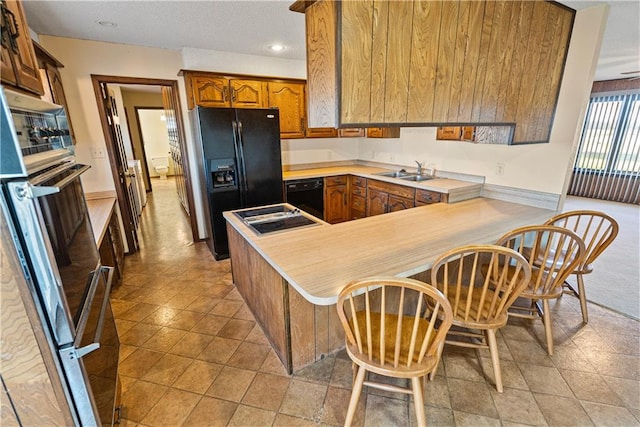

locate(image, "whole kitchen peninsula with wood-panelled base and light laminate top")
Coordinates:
224 198 555 372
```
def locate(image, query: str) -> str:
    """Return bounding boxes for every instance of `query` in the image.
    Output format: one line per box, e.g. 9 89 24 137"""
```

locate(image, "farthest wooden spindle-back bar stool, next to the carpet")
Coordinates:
545 210 618 323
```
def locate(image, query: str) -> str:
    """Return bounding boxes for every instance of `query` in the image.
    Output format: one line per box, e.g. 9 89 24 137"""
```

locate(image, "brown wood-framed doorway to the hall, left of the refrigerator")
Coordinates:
91 75 198 254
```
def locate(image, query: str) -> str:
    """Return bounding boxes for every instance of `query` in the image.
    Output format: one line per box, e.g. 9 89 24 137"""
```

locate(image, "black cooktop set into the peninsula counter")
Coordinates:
235 205 318 234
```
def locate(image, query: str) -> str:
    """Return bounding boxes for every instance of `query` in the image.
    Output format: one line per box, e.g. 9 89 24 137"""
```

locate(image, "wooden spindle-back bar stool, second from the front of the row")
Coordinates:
430 245 531 393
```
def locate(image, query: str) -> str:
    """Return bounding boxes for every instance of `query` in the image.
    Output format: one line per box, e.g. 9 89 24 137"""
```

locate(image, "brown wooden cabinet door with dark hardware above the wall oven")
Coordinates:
2 0 44 95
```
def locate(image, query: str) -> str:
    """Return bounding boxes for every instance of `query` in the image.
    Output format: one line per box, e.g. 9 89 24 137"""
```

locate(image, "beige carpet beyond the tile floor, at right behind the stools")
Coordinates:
563 196 640 319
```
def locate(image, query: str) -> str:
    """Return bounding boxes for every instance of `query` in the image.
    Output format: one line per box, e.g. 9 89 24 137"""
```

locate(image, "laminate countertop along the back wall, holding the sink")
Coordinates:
282 165 482 203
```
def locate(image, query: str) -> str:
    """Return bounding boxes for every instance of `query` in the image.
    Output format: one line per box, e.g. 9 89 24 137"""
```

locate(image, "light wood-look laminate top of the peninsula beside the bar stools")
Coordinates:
224 198 555 305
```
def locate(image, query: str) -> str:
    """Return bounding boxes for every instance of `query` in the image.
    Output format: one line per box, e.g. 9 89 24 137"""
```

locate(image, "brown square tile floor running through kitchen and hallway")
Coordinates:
112 180 640 426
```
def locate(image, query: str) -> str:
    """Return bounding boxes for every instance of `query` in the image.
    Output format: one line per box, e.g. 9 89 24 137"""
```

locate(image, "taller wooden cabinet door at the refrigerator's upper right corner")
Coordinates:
269 82 306 139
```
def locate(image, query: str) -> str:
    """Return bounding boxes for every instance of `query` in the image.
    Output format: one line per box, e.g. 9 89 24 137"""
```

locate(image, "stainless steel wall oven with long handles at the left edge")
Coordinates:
0 86 119 425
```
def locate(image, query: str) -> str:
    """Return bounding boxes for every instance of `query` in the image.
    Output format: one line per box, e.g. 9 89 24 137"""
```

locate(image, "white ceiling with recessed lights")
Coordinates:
24 0 640 80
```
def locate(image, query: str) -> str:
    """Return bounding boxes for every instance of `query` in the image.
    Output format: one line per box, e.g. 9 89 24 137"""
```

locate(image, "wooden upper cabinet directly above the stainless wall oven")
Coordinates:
0 0 44 95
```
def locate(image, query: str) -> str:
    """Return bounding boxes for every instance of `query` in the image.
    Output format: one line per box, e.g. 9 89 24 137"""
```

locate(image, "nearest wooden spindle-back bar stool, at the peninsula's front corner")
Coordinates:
337 277 453 426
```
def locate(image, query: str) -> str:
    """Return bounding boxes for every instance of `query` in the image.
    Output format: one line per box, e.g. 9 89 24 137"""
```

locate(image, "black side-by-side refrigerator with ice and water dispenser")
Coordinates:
191 107 284 260
